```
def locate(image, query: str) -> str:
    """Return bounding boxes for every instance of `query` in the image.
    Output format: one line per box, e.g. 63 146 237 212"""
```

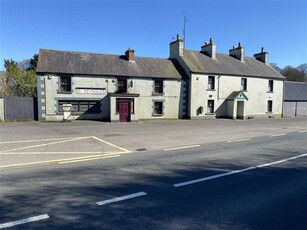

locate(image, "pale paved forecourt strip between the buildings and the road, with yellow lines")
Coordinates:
0 118 307 169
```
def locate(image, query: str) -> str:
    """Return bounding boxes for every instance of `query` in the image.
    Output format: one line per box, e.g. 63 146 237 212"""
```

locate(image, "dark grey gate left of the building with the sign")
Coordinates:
4 97 37 121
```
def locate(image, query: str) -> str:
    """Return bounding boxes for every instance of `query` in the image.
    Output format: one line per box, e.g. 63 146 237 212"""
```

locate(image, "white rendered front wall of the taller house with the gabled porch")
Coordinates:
190 74 283 118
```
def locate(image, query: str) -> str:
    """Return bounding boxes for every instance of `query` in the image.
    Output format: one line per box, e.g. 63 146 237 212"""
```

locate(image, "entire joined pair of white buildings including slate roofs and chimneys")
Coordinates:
37 36 284 122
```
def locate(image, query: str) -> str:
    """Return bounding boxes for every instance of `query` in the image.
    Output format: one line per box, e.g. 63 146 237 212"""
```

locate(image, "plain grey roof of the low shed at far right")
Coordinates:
284 81 307 101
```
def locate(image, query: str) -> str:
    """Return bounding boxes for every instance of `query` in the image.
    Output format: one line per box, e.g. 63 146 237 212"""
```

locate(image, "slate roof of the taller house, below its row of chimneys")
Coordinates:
182 50 284 79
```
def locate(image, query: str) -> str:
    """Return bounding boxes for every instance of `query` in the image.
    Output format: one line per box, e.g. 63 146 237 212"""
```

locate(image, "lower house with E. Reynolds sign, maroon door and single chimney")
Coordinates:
37 49 186 122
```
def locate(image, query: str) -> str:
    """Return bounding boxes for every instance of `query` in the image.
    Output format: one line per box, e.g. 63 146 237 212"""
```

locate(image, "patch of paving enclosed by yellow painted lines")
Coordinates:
0 136 130 170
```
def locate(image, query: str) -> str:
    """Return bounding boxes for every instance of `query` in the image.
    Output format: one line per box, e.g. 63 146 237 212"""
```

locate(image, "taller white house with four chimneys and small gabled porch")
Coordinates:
170 36 284 119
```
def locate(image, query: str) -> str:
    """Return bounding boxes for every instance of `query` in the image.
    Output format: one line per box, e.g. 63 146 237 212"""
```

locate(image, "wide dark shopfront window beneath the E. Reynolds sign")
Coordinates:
58 100 101 113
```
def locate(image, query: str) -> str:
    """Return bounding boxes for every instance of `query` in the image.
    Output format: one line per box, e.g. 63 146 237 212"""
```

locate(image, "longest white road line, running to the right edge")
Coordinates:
173 153 307 187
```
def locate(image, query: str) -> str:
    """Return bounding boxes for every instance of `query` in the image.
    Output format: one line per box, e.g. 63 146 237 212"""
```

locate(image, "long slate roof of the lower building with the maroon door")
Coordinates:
36 49 185 79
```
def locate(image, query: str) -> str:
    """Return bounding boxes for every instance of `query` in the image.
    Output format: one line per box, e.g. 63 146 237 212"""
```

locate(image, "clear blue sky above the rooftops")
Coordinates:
0 0 307 69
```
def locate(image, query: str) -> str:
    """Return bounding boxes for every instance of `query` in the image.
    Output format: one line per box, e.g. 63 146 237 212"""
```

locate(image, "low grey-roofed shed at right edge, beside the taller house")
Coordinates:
283 81 307 117
